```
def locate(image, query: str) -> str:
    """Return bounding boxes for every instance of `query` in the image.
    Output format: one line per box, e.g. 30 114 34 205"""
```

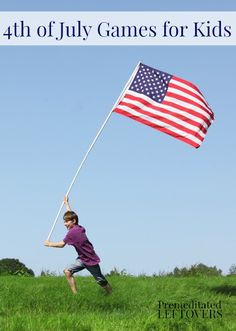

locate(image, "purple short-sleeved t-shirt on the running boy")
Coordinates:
63 225 100 266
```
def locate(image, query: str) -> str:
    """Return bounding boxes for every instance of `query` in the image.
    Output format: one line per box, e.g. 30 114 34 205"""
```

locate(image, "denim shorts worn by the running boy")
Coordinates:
66 259 108 286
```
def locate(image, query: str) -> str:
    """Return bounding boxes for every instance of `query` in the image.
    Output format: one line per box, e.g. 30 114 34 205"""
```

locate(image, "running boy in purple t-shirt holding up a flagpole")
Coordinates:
44 197 112 293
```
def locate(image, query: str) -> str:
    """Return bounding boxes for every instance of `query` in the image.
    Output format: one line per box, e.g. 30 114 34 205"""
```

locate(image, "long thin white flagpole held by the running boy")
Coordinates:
47 62 141 240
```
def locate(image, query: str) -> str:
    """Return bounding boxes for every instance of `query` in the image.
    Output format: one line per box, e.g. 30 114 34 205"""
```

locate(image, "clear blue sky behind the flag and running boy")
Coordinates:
0 0 236 274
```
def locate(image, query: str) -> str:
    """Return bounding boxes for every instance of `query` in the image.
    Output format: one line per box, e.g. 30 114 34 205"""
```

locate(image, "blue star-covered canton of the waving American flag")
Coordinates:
129 64 172 103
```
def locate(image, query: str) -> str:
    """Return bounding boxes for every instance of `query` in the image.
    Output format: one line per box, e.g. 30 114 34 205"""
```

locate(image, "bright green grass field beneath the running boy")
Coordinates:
0 276 236 331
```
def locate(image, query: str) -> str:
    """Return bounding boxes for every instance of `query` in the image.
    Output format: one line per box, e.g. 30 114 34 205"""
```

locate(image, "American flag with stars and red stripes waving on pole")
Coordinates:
113 63 214 148
